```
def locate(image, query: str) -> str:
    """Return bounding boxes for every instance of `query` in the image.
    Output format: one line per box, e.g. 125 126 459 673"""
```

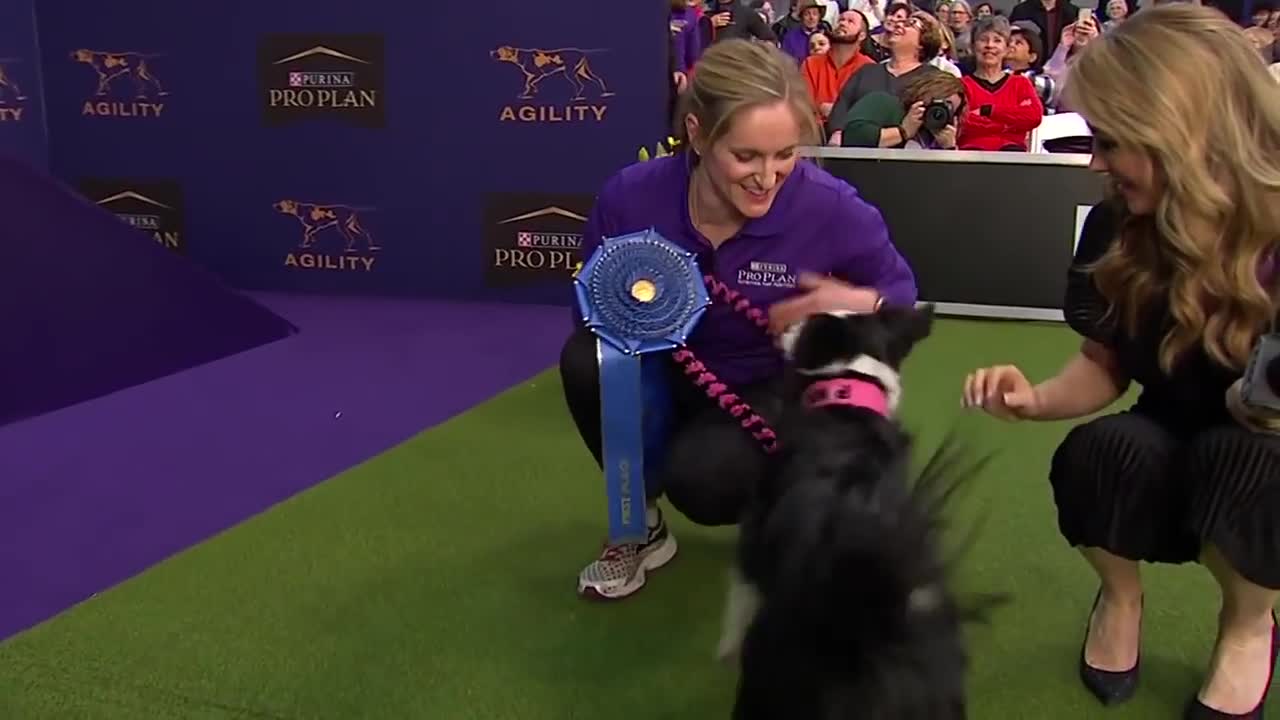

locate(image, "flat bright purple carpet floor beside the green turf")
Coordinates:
0 295 568 639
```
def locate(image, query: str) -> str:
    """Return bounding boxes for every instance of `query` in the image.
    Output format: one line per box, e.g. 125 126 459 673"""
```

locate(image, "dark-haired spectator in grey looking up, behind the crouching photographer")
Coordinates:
827 12 946 145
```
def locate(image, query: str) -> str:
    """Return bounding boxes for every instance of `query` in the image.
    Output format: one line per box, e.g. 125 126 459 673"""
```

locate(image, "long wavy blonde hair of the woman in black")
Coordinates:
1064 4 1280 373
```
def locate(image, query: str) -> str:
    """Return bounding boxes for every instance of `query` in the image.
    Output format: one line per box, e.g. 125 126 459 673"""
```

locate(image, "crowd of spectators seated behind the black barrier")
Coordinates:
669 0 1280 151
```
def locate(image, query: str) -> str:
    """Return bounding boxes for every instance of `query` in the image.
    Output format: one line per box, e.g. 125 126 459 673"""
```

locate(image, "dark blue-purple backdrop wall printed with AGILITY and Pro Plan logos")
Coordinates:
0 0 667 302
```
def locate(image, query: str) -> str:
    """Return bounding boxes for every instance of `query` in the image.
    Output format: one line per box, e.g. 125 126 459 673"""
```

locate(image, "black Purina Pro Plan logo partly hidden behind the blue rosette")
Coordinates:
485 193 593 287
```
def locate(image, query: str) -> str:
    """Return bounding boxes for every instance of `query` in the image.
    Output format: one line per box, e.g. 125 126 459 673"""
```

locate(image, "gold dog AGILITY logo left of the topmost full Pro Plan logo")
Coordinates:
72 47 169 118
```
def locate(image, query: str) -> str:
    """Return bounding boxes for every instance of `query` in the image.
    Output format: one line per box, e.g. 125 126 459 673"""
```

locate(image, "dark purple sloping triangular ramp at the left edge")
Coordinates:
0 158 294 425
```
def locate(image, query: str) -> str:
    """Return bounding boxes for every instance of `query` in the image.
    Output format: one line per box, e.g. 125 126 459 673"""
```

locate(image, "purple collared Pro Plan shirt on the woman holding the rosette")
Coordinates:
582 152 916 384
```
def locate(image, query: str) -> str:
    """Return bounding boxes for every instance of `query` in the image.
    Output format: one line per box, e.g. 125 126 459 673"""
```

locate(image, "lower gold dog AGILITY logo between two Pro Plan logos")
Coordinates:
273 200 381 273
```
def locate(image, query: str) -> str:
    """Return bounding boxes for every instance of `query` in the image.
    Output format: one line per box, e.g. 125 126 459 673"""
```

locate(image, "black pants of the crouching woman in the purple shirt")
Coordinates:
559 328 781 525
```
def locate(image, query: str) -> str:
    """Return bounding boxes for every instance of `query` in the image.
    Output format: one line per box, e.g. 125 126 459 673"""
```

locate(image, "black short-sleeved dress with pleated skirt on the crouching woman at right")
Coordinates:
1050 198 1280 589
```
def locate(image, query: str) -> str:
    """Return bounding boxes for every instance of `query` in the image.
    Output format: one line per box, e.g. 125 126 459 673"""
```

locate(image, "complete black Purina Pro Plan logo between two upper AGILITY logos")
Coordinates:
259 35 387 128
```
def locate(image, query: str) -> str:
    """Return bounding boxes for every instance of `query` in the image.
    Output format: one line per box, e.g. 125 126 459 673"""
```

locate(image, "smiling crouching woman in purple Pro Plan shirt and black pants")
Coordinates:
559 40 916 598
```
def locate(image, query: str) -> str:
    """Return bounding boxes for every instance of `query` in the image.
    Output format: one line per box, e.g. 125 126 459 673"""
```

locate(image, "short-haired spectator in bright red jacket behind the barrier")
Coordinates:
957 15 1044 152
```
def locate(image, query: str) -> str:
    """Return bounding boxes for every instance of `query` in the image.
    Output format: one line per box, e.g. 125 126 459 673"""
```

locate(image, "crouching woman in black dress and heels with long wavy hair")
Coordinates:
963 4 1280 719
